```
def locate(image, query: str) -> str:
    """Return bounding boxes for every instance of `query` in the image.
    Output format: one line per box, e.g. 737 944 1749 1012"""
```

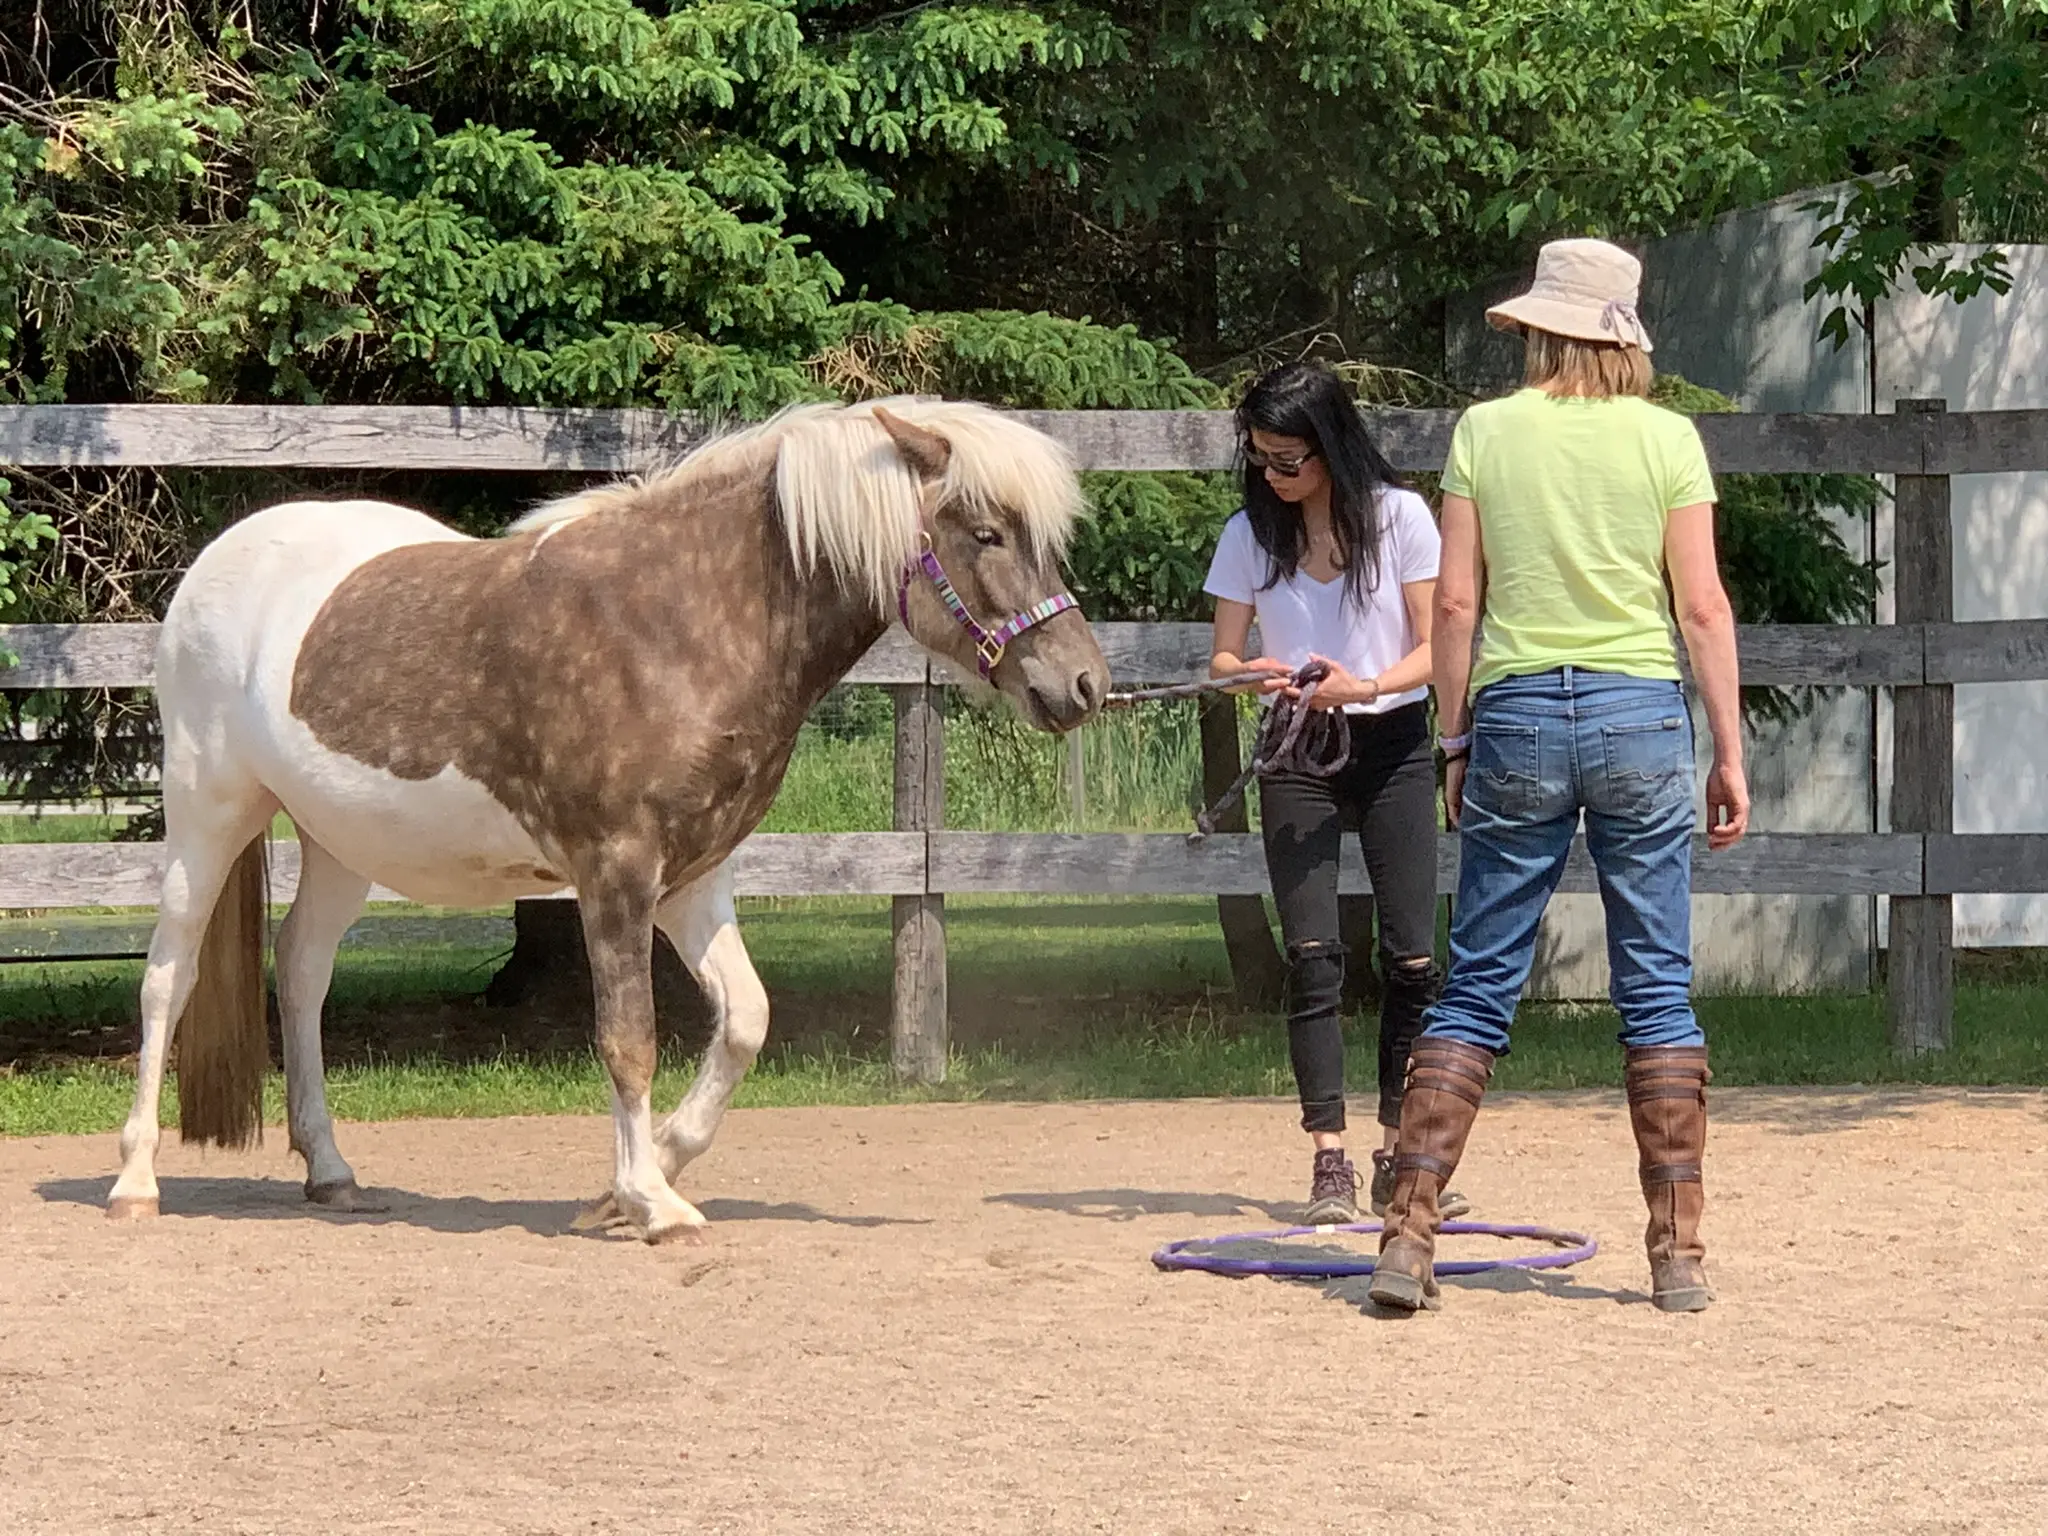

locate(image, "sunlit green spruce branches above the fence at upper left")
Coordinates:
0 0 1155 414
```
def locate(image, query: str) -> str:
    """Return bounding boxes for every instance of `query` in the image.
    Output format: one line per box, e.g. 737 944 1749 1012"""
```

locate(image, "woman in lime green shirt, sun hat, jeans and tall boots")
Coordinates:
1372 240 1749 1311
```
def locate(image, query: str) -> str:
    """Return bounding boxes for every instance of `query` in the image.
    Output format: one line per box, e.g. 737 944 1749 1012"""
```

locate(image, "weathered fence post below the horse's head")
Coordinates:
889 678 948 1083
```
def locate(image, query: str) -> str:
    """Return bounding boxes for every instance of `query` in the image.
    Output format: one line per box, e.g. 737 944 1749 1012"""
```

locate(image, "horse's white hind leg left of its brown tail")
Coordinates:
106 774 276 1221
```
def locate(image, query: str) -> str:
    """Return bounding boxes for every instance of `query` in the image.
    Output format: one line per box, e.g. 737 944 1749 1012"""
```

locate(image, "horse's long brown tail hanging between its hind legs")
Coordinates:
174 836 270 1147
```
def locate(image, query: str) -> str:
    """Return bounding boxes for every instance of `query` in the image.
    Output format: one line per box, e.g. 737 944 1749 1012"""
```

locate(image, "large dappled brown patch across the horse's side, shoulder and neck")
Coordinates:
291 442 885 895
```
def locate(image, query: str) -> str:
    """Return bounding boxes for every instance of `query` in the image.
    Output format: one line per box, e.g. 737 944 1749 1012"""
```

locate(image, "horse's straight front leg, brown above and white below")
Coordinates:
578 881 705 1243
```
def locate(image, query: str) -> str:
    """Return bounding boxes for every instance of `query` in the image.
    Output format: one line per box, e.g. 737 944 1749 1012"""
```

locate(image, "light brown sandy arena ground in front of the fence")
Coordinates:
0 1090 2048 1536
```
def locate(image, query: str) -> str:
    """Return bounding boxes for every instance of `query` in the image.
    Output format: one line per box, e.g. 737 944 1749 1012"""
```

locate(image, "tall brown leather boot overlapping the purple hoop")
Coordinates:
1368 1036 1493 1313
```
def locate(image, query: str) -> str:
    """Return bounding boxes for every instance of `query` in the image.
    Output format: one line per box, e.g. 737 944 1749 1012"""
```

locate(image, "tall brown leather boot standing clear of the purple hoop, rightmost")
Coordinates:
1628 1044 1714 1313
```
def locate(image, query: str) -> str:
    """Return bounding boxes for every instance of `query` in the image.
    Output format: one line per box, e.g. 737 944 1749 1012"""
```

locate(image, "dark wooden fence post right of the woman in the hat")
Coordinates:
1888 399 1956 1057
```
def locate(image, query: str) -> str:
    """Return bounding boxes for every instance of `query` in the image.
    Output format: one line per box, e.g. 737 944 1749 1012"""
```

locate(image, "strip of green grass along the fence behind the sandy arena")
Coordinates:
0 899 2048 1135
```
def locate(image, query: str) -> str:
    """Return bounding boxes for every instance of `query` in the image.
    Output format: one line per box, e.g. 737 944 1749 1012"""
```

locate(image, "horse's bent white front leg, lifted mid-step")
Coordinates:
655 864 768 1184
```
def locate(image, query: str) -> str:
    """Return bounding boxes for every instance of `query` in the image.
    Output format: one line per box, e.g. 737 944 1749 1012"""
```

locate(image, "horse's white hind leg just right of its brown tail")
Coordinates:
276 827 371 1210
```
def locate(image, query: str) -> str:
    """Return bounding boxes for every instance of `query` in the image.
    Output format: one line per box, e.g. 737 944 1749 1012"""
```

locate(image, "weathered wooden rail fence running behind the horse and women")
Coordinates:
0 401 2048 1077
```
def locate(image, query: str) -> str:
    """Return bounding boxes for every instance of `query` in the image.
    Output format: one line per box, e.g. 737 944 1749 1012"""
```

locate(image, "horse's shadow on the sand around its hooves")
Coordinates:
35 1176 926 1239
